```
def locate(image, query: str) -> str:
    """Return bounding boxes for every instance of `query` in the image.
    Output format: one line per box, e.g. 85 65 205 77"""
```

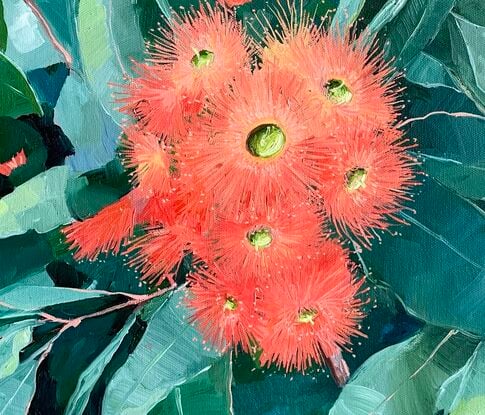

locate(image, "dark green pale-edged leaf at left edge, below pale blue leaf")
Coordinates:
0 53 42 118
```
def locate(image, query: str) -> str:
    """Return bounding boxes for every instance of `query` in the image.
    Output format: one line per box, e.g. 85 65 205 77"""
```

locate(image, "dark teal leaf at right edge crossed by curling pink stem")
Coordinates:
407 87 485 199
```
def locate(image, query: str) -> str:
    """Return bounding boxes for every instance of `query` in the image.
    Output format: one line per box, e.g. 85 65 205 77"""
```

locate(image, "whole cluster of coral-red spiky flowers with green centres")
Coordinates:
61 2 415 380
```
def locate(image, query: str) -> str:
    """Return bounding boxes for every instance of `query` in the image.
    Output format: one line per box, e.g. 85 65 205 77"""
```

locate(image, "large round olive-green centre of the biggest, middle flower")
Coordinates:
246 124 286 159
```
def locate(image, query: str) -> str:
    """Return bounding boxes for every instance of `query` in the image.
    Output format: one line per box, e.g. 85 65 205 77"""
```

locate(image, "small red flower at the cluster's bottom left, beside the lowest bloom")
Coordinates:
188 267 261 351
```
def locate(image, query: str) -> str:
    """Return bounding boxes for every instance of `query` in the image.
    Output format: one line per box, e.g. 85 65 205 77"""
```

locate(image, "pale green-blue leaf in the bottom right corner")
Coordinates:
435 342 485 415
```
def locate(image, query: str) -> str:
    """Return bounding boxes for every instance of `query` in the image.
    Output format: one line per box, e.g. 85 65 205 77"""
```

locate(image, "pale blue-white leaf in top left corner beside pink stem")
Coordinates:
4 0 63 72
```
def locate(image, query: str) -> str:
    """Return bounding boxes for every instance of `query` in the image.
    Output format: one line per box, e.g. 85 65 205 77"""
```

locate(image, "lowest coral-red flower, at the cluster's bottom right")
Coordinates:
257 242 363 371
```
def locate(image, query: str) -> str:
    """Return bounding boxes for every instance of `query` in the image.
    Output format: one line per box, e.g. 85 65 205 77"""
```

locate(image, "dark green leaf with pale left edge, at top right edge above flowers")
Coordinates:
369 0 455 68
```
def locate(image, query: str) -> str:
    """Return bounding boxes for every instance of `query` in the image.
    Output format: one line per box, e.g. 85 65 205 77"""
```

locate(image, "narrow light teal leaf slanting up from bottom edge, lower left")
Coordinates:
64 314 136 415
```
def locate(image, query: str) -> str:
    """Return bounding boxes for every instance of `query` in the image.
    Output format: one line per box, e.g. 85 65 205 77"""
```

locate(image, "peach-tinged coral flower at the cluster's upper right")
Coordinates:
263 12 401 130
